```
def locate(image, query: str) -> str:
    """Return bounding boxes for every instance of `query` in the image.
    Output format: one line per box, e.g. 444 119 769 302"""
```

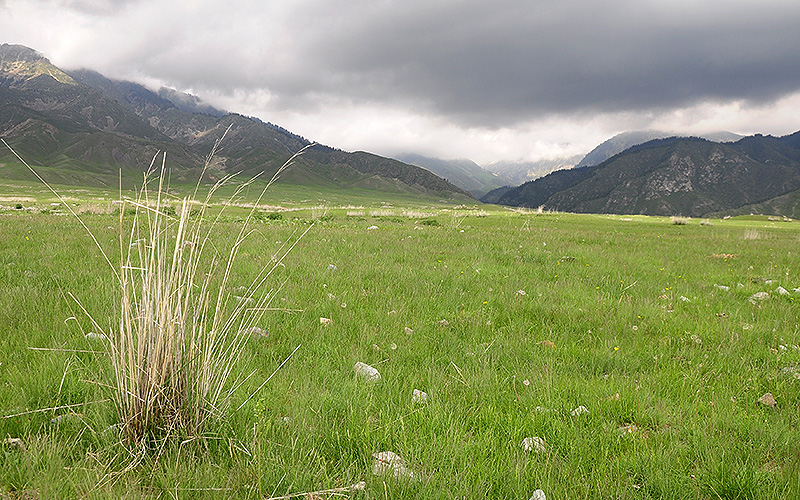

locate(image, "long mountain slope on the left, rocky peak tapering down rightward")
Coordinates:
0 44 472 200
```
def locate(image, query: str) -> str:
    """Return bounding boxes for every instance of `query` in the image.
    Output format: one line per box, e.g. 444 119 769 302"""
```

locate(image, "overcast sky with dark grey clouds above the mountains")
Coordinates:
0 0 800 165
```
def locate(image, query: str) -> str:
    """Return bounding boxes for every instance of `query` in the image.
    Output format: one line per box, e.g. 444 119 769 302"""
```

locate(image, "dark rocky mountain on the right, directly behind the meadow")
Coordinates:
498 132 800 217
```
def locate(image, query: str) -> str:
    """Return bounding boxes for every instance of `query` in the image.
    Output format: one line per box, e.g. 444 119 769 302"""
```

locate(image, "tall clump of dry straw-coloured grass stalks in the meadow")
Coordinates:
3 131 313 444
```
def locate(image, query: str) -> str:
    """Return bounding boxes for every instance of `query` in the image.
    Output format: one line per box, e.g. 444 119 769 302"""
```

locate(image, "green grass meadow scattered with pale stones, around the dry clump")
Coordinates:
0 190 800 499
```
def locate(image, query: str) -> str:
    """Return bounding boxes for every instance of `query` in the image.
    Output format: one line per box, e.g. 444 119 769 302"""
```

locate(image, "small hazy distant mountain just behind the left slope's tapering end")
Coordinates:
397 154 511 197
